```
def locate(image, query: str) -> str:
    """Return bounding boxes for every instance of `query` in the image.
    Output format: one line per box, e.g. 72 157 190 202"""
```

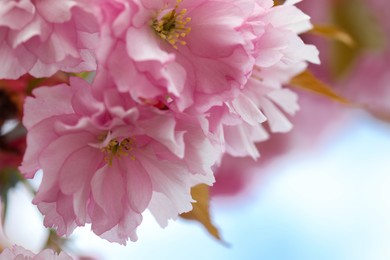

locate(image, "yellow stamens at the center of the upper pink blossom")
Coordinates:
152 0 191 49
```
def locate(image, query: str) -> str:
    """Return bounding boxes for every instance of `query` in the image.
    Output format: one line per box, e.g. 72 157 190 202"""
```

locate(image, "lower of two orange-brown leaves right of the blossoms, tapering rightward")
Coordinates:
289 70 350 104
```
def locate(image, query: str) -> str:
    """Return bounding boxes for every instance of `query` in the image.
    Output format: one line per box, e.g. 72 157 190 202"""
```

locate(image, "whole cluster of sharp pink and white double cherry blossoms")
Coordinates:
0 0 319 244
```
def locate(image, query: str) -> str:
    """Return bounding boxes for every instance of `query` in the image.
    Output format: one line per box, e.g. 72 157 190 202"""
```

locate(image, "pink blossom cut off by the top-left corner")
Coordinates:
0 0 97 79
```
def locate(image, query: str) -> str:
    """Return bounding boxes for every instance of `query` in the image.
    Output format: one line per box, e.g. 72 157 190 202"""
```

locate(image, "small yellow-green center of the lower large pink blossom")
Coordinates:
102 137 136 166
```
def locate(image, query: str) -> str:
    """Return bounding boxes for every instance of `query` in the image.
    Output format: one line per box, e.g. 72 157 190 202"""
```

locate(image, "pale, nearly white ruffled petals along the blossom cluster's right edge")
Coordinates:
210 2 319 159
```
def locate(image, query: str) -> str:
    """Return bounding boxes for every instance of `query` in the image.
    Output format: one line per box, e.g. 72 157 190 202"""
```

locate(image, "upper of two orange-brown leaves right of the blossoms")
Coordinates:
309 24 355 47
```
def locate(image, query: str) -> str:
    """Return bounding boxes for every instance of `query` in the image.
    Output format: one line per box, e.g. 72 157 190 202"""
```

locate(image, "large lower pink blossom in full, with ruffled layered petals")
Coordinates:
20 73 218 244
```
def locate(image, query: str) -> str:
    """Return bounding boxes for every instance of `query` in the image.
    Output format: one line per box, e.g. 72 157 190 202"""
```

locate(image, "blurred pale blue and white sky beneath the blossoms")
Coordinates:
5 112 390 260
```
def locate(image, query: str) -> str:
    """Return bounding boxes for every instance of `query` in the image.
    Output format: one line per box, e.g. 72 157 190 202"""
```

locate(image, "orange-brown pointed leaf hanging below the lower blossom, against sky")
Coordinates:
180 184 223 242
